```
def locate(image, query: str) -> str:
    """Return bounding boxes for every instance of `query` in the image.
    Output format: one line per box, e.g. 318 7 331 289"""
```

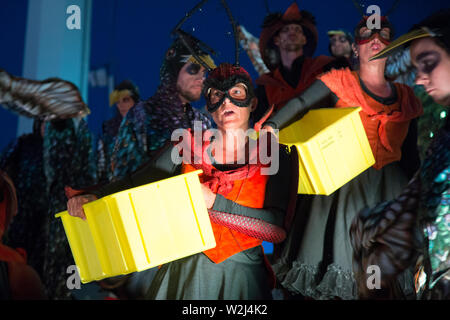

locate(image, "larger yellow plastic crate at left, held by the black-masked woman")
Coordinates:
55 170 216 283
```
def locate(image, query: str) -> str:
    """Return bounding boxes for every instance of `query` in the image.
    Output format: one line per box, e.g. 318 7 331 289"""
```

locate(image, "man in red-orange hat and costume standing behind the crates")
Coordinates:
254 3 348 121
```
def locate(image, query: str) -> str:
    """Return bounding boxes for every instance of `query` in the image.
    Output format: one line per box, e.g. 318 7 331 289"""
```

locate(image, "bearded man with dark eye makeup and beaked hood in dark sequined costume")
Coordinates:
108 35 215 180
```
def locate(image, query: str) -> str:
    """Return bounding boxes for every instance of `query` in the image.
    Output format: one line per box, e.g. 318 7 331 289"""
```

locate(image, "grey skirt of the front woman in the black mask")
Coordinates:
146 246 272 300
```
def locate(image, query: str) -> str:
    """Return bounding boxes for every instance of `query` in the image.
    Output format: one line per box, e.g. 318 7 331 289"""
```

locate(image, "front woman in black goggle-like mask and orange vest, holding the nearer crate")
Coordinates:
63 63 298 300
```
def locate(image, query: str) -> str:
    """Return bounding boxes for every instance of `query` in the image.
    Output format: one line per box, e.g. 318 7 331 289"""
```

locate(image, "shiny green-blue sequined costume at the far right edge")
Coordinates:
417 120 450 299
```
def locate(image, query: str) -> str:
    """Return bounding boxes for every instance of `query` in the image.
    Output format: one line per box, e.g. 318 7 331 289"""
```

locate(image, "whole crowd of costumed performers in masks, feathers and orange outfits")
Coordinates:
0 1 450 300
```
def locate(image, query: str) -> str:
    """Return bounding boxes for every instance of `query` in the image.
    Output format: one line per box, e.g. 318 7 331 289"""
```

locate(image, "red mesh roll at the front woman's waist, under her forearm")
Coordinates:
208 210 286 243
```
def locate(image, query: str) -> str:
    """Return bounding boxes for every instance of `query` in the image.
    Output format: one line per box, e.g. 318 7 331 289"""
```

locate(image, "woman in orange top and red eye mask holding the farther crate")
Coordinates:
265 17 422 299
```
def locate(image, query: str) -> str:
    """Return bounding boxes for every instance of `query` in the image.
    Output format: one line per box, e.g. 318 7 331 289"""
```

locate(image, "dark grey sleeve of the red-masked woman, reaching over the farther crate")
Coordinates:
264 80 334 129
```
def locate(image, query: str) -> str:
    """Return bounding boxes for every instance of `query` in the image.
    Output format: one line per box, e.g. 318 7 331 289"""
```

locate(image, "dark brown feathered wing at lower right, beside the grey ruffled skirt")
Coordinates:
350 174 420 299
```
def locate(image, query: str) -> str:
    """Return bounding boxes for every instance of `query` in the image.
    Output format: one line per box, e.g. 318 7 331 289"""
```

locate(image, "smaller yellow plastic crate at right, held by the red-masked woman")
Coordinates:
280 107 375 195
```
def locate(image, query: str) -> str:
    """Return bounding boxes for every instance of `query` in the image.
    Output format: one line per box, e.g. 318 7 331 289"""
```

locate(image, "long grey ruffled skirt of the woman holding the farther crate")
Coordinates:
273 163 414 300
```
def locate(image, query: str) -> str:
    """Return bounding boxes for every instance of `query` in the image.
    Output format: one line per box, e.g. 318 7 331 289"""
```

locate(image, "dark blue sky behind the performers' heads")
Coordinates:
0 0 448 149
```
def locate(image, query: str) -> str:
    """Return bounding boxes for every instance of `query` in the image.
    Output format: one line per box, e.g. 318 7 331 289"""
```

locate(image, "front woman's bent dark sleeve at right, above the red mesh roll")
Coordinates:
212 148 292 226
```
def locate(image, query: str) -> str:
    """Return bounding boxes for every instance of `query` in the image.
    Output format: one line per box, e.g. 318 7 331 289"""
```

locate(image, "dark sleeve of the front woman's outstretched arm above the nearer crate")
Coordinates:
90 144 181 198
